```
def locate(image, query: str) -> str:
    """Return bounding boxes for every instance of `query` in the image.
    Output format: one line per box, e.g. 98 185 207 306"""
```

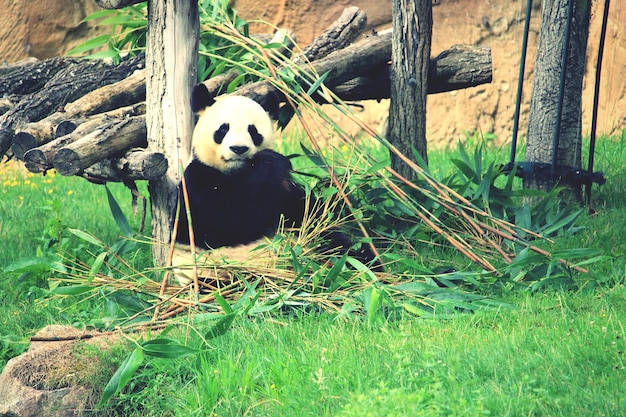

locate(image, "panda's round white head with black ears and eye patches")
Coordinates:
191 84 278 173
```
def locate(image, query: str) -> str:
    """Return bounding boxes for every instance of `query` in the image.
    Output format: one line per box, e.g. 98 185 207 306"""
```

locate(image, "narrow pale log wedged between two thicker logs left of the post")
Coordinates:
22 102 146 173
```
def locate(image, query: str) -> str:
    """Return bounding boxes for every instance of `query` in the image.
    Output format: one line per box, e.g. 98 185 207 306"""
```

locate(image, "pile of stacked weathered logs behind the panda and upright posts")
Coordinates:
0 7 491 182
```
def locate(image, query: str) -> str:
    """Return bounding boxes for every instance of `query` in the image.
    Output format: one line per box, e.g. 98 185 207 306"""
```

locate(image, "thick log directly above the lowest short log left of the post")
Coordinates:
53 115 148 175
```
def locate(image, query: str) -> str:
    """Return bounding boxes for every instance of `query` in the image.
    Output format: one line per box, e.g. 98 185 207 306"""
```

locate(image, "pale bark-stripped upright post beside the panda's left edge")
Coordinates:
146 0 200 266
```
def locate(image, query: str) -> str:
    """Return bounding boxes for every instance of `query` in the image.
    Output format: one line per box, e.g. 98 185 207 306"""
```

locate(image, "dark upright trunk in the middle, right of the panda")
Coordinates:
387 0 433 178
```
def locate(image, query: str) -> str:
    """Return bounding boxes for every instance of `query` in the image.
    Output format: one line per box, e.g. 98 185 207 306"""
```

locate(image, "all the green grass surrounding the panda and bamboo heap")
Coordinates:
0 133 626 416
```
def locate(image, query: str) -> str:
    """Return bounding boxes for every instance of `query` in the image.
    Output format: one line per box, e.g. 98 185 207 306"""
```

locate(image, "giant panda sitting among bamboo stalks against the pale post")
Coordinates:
168 84 374 284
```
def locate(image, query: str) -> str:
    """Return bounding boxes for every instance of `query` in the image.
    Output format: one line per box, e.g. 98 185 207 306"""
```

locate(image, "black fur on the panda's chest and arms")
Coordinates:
176 149 305 249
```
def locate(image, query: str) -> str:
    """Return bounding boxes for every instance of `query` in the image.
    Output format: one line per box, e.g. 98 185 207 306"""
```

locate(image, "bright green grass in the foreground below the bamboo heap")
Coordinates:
100 287 626 416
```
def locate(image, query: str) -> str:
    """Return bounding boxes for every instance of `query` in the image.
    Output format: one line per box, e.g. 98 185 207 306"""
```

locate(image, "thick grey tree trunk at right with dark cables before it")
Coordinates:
524 0 591 194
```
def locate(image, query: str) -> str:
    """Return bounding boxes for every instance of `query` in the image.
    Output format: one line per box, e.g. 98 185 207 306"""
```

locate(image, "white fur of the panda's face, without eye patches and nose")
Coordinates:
192 95 274 172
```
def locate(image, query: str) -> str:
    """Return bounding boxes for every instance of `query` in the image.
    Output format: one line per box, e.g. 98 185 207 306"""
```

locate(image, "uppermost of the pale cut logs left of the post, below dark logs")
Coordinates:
13 70 146 159
